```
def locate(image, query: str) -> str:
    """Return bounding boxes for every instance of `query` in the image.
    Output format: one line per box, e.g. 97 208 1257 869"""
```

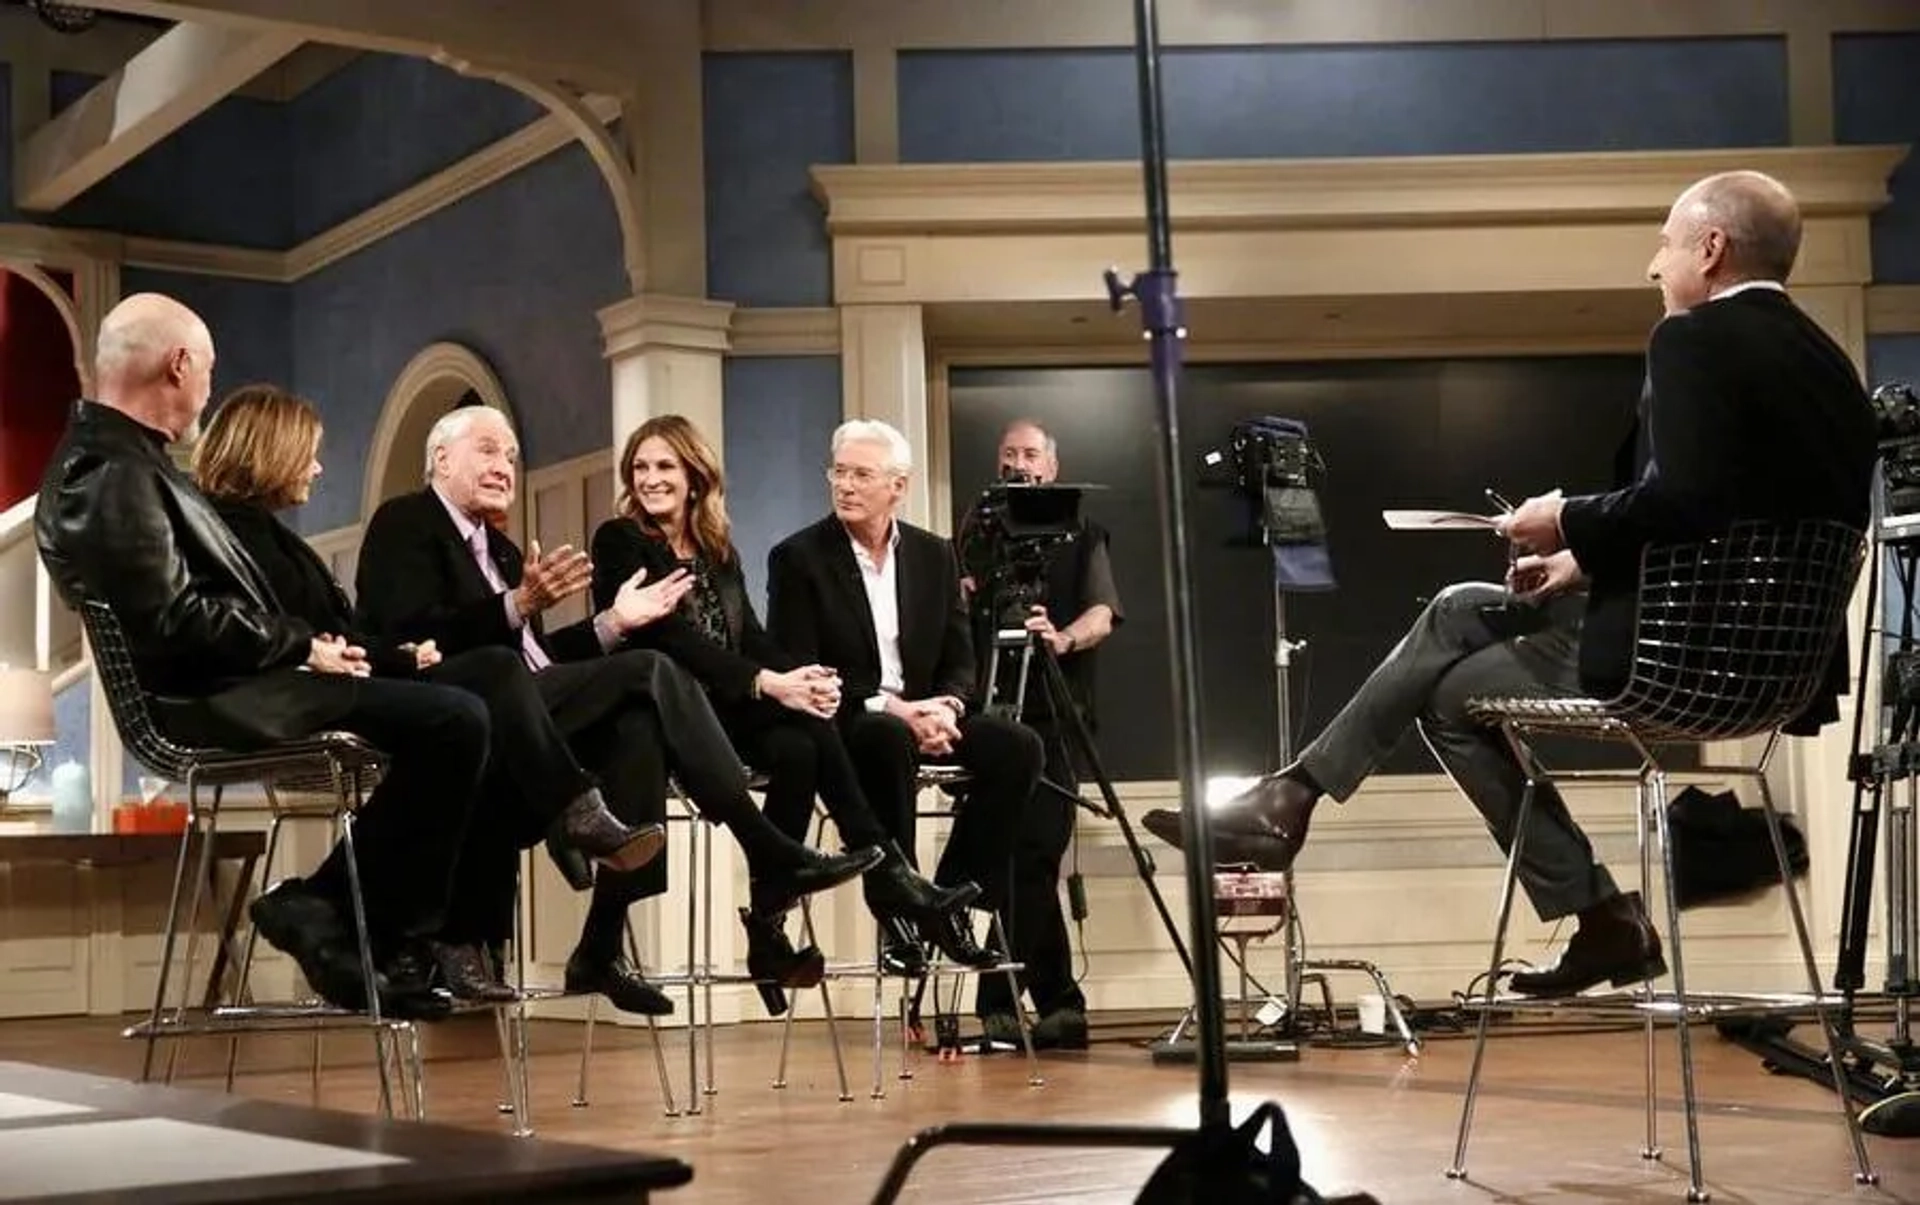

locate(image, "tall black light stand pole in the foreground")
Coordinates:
1106 0 1233 1130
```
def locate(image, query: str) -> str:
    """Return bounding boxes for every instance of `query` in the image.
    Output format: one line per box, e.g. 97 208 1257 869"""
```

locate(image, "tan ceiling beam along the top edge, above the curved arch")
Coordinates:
82 0 651 94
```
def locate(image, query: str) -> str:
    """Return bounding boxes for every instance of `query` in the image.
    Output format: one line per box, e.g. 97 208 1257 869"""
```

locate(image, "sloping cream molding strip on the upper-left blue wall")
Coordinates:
282 96 620 282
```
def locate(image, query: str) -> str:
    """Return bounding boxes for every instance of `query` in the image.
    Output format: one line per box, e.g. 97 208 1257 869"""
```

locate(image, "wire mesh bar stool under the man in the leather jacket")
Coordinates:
81 599 424 1117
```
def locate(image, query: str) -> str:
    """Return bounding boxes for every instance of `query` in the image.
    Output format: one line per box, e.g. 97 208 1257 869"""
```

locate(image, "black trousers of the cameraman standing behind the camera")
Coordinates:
973 716 1087 1017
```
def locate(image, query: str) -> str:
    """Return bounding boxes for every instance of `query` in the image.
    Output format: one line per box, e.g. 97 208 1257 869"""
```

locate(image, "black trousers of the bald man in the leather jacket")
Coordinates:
167 670 490 954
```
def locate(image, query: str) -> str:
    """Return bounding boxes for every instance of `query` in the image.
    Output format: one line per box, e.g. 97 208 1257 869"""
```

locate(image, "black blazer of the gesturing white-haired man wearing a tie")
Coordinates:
353 487 601 662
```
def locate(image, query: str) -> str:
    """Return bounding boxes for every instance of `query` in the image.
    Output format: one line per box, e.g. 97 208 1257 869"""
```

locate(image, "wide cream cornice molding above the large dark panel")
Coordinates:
812 146 1908 305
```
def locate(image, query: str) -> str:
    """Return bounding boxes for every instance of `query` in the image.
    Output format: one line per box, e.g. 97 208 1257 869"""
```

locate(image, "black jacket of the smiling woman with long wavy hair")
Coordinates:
591 518 795 702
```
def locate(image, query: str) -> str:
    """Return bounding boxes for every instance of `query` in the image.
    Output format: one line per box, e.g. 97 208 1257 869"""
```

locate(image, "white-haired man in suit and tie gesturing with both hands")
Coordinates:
355 407 881 1013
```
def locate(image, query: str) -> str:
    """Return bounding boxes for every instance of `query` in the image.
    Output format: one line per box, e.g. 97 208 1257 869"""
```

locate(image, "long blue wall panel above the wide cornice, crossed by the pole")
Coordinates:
899 38 1788 163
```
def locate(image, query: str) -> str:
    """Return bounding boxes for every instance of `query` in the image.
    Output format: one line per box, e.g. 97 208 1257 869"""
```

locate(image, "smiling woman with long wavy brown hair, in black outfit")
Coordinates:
593 414 979 1005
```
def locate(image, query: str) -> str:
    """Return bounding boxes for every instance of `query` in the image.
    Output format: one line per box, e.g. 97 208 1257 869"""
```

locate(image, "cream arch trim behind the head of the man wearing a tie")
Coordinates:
361 335 520 535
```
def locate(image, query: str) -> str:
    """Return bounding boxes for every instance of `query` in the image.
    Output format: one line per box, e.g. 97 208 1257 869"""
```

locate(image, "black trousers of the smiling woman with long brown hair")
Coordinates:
714 698 891 850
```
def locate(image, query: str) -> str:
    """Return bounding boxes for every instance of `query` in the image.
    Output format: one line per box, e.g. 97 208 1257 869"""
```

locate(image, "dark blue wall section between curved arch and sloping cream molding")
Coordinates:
286 54 545 240
